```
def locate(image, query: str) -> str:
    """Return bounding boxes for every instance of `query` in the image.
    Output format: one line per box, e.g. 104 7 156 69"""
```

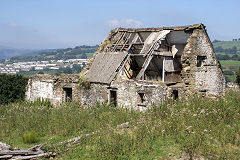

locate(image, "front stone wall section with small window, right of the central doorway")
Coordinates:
111 80 167 109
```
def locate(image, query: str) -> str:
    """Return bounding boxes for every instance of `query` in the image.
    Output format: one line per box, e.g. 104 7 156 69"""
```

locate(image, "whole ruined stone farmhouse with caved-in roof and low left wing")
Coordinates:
26 24 225 108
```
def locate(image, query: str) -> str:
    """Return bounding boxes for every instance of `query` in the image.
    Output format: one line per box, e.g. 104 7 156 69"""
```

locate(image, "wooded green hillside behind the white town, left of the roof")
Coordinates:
10 45 98 62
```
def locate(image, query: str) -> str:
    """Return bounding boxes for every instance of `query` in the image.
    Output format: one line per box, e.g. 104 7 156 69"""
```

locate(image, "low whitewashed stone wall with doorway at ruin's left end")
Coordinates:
26 75 80 104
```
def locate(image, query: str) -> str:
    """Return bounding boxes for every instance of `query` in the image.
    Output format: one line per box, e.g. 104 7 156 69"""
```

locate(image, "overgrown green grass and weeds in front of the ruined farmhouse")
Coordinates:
0 91 240 160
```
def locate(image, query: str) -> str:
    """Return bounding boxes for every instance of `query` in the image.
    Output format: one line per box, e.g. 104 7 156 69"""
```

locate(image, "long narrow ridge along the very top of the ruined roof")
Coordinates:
118 23 205 32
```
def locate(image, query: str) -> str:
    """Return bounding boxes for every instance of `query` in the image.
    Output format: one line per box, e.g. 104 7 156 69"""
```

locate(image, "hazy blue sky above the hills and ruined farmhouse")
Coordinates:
0 0 240 49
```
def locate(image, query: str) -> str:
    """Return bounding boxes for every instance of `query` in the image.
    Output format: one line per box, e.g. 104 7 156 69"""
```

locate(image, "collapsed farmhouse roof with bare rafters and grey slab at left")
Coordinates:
86 24 205 84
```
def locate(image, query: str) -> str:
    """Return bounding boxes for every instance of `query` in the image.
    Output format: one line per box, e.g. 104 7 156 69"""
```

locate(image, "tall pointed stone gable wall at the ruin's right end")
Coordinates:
181 29 225 96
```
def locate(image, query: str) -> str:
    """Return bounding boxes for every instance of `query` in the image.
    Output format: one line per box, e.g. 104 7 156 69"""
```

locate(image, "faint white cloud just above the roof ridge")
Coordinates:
107 18 143 27
